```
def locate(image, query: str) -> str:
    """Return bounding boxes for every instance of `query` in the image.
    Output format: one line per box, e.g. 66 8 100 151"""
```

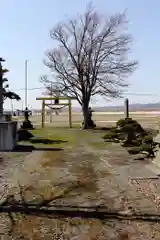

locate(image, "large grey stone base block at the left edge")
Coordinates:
0 121 17 151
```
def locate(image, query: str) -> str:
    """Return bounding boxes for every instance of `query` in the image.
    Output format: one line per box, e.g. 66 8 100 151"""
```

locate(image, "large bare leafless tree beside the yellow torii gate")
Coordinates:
42 6 137 128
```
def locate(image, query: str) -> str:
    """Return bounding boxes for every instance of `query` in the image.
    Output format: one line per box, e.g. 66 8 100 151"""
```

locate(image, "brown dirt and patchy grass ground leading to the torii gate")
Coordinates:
0 116 160 240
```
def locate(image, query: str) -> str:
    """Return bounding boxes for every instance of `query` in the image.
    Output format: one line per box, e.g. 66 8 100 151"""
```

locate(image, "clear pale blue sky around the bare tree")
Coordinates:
0 0 160 109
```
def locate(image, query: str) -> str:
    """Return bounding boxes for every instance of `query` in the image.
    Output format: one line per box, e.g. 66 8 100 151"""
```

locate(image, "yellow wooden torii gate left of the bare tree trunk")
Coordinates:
36 97 76 128
